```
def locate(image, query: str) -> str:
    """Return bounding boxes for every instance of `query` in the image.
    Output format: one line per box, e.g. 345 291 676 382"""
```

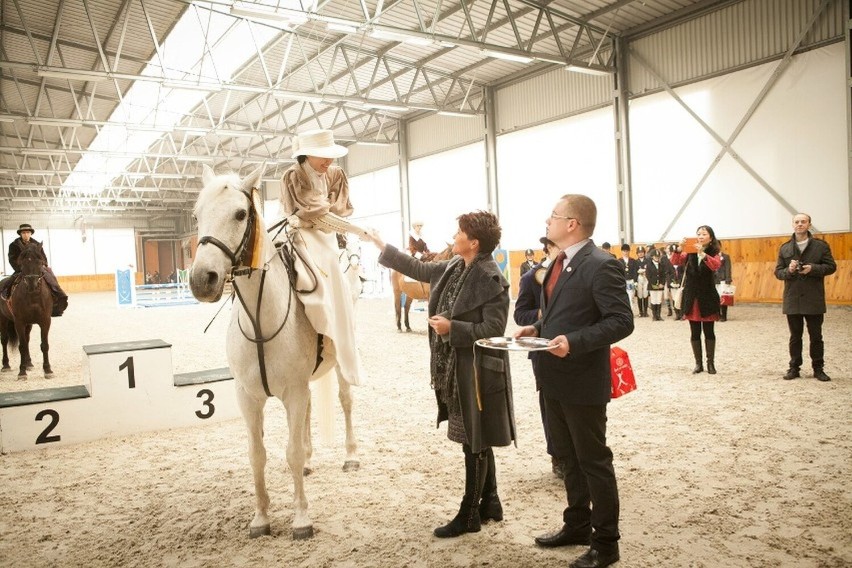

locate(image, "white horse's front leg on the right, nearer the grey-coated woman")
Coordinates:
284 381 314 540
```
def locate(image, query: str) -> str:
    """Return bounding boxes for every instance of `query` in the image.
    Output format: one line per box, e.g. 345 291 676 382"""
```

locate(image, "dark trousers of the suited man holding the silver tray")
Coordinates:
545 397 620 553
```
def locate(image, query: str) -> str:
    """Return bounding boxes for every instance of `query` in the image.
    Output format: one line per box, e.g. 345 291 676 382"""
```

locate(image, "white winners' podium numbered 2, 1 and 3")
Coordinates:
0 339 239 453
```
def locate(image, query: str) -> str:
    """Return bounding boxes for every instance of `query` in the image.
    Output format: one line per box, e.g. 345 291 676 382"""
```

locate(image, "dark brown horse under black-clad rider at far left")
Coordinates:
0 243 53 380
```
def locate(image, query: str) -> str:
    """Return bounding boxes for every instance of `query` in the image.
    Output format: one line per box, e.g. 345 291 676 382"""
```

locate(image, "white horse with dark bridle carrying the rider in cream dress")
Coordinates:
189 165 358 539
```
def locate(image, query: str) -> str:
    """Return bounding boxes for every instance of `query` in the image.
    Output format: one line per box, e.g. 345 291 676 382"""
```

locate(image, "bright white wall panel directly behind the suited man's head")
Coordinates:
497 108 619 250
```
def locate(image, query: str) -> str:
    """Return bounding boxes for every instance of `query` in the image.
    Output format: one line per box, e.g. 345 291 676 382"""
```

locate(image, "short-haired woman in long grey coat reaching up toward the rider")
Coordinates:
364 211 515 538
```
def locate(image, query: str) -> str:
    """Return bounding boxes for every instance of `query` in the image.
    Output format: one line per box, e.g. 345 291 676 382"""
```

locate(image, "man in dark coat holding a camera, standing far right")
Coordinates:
775 213 837 381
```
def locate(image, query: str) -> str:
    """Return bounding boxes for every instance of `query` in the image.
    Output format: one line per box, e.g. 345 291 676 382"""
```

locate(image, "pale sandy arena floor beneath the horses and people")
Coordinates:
0 293 852 568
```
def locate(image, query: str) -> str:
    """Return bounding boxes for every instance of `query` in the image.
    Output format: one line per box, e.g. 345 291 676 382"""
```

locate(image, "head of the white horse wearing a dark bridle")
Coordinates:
189 165 262 302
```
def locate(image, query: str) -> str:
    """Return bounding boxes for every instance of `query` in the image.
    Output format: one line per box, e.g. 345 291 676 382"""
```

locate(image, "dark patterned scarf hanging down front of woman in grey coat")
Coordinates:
430 253 491 414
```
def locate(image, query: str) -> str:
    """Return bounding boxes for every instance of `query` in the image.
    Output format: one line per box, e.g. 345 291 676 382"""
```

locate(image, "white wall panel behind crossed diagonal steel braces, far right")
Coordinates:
630 43 850 242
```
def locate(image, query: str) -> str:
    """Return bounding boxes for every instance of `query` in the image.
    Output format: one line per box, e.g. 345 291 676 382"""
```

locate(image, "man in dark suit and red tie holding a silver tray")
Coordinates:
515 194 633 568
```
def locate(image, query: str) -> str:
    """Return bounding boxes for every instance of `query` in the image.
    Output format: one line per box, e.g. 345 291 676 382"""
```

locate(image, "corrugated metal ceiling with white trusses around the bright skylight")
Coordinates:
0 0 764 223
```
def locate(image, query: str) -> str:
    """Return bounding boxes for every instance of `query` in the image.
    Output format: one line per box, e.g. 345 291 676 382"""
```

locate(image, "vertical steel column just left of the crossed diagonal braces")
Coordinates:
612 38 633 243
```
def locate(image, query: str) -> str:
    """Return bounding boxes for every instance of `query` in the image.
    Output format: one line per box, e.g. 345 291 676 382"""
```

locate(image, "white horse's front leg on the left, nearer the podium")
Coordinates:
237 383 271 538
